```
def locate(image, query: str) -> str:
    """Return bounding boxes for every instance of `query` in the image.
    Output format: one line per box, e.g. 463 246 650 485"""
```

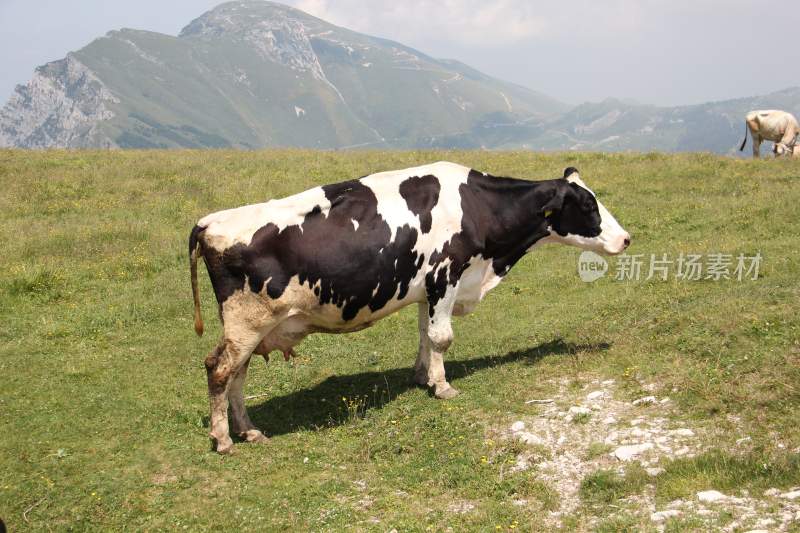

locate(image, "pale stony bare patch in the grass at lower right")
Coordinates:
499 380 800 531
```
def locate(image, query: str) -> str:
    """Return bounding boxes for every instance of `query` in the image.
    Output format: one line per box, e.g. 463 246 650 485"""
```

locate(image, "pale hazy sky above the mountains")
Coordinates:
0 0 800 105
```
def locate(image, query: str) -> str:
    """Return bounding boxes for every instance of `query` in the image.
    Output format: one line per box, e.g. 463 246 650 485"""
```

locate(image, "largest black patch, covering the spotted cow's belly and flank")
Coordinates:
200 180 422 321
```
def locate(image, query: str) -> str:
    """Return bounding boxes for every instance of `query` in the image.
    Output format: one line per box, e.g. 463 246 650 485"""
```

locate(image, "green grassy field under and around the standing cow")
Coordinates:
0 150 800 532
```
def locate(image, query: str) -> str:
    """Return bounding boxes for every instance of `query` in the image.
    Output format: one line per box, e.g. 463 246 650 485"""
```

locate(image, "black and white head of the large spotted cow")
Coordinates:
542 167 631 255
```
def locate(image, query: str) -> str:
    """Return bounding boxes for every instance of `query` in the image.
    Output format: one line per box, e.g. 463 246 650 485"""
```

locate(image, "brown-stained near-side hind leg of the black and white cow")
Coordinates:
205 332 261 454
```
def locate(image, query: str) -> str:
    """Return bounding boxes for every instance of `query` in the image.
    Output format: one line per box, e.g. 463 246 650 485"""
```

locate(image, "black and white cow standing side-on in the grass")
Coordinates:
189 162 630 453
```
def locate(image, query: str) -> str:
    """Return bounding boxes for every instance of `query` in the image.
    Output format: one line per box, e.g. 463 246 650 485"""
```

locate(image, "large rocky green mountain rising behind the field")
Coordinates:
0 1 567 148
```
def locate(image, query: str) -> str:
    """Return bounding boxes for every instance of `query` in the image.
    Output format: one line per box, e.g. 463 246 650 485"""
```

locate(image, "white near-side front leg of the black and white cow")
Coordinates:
420 287 458 400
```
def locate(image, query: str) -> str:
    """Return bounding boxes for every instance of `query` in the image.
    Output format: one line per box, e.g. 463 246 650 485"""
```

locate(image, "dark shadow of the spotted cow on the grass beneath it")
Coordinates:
248 339 610 436
